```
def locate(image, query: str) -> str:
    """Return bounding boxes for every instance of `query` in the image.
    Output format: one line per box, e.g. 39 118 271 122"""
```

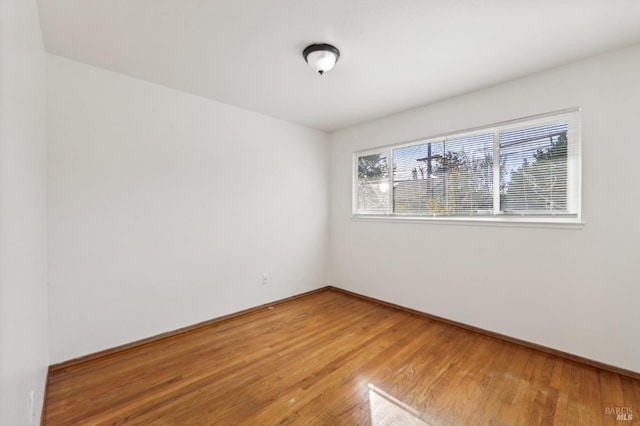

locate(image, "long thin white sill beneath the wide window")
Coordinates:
351 214 586 229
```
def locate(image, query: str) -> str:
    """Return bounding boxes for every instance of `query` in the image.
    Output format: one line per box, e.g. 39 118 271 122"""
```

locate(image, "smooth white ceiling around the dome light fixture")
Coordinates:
38 0 640 131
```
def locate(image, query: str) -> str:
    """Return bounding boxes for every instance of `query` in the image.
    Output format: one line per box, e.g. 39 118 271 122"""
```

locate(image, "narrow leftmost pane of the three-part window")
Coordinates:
357 153 390 214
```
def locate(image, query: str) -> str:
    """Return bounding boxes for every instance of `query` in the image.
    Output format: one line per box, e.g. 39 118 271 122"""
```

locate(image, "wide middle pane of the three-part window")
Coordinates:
393 133 493 215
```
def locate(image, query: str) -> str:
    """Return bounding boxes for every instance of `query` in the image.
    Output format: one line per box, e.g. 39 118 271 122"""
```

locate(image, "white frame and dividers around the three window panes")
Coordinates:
352 108 583 227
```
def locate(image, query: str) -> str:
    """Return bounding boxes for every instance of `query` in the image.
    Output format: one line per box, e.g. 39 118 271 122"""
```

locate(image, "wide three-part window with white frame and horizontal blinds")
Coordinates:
353 110 580 222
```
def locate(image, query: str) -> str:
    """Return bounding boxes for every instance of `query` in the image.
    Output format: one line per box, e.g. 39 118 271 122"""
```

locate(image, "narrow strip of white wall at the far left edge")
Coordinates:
0 0 48 426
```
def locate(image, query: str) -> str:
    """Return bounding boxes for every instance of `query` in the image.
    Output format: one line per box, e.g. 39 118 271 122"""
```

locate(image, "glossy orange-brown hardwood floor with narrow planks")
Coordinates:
43 290 640 426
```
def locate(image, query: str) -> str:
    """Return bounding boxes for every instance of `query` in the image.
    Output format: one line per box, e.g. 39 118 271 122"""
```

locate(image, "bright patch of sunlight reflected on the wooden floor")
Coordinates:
369 383 429 426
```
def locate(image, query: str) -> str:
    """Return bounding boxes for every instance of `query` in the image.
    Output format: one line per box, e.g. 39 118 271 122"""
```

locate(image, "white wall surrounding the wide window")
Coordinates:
330 46 640 372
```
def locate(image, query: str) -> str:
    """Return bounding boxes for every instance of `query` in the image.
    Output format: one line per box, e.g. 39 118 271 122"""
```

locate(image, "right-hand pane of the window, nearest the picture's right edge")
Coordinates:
500 123 568 213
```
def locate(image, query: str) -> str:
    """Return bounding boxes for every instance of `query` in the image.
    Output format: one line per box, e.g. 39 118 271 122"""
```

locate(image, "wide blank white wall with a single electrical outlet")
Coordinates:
47 55 329 363
